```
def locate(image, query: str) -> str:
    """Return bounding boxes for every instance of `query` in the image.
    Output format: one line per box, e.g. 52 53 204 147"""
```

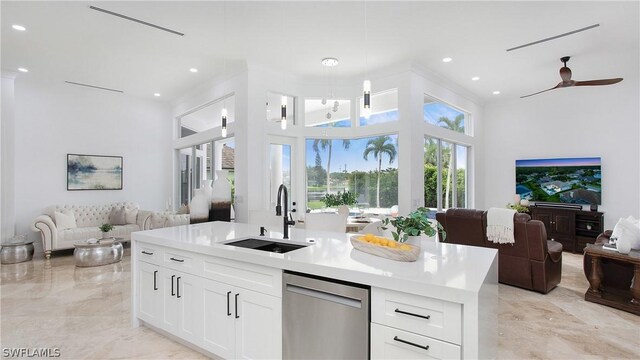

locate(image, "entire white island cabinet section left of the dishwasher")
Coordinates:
134 242 282 359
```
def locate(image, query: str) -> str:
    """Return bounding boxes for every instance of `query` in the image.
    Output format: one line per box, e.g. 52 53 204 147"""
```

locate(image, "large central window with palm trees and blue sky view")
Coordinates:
306 135 398 213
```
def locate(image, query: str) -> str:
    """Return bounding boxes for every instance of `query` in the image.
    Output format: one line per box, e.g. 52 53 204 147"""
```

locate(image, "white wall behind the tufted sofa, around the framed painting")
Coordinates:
14 77 172 250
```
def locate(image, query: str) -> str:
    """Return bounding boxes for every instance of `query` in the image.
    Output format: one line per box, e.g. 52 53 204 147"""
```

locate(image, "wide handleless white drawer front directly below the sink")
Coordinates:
203 256 282 298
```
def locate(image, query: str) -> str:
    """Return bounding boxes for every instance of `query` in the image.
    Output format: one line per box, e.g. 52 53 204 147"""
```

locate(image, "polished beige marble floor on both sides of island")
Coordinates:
0 249 640 359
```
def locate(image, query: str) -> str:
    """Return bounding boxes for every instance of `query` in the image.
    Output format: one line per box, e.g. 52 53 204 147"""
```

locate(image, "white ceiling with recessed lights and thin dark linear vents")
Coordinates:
1 1 640 101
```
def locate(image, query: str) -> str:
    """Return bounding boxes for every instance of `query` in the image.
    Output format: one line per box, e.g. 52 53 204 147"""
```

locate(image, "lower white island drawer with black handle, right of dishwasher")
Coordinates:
371 323 462 359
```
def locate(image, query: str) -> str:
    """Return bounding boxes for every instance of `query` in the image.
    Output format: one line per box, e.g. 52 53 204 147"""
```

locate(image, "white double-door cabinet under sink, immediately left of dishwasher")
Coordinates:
201 279 282 359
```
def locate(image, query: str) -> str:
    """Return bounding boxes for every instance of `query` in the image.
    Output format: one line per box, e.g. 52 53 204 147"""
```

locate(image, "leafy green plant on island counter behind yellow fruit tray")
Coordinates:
382 207 446 243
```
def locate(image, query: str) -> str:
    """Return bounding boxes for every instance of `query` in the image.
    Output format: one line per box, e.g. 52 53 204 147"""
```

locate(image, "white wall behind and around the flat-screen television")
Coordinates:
480 75 640 229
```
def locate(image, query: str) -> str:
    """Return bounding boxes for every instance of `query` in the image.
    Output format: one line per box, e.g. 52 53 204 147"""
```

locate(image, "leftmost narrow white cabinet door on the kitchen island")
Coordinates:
137 261 162 326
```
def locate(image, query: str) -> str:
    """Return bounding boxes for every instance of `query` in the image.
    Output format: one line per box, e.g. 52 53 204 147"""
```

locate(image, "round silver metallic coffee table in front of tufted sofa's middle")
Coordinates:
73 238 124 267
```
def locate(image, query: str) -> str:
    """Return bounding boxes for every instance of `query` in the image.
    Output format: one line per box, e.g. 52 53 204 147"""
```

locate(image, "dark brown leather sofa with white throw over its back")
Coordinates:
436 209 562 294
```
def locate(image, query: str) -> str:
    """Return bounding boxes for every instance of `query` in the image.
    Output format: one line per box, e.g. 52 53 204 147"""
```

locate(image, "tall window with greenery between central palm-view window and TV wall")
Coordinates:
424 137 469 211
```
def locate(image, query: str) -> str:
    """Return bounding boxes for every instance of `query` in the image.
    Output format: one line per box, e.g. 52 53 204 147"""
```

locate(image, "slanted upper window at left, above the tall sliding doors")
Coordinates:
179 94 235 137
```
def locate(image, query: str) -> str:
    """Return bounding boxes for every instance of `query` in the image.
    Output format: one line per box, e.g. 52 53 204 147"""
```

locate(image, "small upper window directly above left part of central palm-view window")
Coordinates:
304 98 351 127
